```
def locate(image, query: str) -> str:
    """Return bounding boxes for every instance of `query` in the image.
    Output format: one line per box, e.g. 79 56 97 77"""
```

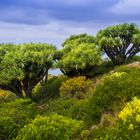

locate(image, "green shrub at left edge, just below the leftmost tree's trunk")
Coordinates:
0 99 36 126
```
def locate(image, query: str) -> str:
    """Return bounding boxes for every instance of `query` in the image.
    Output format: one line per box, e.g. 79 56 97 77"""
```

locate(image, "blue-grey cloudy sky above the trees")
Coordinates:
0 0 140 47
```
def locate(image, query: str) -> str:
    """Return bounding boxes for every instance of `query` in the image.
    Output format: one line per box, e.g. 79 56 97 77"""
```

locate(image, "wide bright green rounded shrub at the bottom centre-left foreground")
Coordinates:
16 114 83 140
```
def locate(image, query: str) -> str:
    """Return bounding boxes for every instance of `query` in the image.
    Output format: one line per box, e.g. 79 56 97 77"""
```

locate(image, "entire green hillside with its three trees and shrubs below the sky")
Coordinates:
0 24 140 140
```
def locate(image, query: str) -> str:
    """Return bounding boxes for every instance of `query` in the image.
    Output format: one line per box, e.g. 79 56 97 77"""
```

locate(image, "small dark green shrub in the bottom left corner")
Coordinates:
0 117 19 140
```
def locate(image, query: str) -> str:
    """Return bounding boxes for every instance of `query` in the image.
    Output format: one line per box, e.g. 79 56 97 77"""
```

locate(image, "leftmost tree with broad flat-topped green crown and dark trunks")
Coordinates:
0 44 55 98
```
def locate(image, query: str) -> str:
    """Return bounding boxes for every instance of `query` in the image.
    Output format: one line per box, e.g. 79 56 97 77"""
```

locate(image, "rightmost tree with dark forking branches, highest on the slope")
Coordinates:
97 24 140 64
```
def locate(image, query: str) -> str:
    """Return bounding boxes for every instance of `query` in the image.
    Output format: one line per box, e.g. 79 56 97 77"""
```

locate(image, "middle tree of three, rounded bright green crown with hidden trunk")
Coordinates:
58 34 101 77
